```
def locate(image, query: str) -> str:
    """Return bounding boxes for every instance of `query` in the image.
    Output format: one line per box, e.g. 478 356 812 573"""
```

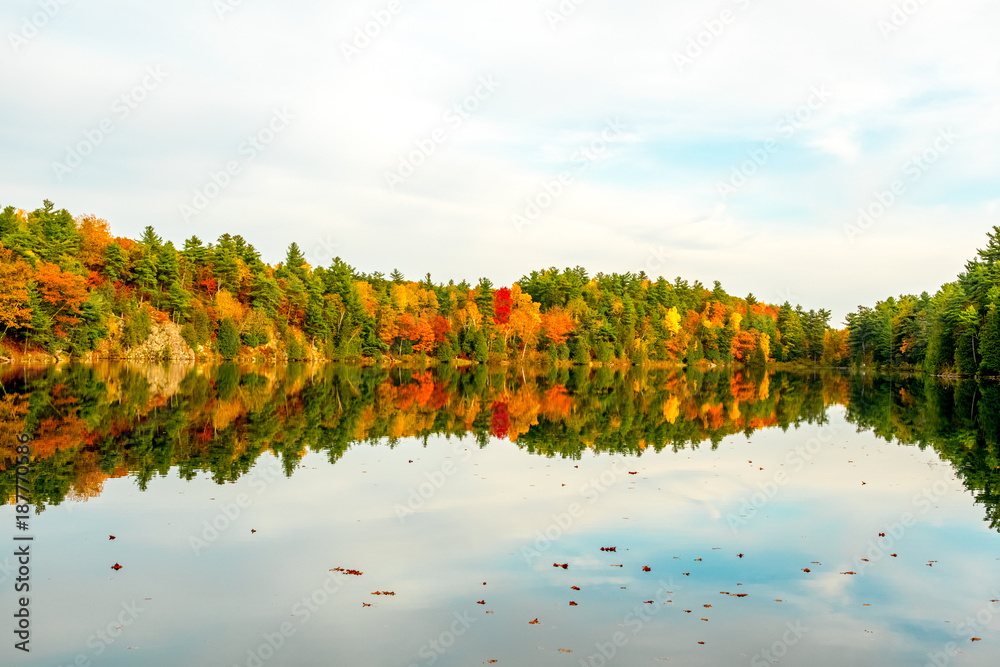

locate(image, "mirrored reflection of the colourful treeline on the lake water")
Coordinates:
0 363 1000 529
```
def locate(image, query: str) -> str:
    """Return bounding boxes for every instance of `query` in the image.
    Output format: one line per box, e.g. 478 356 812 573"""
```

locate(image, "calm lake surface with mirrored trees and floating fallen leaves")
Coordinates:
0 365 1000 667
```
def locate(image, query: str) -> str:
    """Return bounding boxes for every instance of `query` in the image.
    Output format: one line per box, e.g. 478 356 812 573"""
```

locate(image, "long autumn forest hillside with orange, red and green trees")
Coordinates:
0 200 849 366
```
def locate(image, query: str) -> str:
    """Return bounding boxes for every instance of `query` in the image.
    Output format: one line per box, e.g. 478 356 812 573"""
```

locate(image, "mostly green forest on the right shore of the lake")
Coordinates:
847 226 1000 377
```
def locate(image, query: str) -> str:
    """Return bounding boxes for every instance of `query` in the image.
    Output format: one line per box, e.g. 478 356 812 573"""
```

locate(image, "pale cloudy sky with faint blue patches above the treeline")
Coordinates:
0 0 1000 325
